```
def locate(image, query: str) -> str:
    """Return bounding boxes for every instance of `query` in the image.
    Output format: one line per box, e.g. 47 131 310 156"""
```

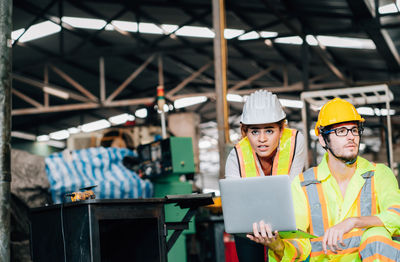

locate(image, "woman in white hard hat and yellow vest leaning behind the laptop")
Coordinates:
225 90 306 262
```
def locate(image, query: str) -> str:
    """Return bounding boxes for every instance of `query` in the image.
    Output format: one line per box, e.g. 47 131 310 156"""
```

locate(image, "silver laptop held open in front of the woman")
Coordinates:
219 175 316 238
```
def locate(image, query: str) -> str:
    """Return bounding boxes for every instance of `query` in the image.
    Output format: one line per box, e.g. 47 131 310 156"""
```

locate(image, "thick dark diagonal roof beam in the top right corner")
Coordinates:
347 0 400 71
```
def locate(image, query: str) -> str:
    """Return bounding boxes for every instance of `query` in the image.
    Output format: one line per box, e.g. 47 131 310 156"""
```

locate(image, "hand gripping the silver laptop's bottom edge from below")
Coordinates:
247 221 285 257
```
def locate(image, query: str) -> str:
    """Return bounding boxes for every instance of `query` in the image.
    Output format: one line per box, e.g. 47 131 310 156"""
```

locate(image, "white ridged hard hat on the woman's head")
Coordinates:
240 90 286 125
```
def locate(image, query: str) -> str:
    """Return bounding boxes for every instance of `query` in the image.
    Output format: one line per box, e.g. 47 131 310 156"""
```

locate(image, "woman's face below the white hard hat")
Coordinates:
246 123 282 157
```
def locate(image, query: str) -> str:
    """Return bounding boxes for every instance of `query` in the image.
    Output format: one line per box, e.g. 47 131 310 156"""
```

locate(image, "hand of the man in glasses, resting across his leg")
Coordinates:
322 217 356 254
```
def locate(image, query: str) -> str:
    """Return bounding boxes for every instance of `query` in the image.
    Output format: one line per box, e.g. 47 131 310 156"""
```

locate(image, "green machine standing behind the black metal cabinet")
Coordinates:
153 137 195 262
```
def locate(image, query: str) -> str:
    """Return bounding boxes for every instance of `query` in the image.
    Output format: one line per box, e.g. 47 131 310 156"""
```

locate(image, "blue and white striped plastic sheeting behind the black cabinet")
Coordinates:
45 147 153 203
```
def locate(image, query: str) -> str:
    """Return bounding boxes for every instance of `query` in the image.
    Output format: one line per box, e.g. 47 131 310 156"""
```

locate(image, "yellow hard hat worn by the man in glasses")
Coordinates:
315 98 365 136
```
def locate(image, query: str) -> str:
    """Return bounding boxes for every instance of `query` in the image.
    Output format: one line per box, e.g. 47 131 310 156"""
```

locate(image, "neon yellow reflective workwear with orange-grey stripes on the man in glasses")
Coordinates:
268 154 400 262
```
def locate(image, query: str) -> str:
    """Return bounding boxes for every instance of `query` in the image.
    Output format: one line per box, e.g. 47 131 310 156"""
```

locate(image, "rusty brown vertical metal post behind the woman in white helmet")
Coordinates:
212 0 230 178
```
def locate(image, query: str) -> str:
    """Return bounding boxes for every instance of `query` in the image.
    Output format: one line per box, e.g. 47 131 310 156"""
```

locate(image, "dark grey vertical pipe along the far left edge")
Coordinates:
0 0 12 261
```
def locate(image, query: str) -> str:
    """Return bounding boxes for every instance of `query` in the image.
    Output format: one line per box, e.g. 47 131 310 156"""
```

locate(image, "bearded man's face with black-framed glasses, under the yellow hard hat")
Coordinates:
319 123 360 161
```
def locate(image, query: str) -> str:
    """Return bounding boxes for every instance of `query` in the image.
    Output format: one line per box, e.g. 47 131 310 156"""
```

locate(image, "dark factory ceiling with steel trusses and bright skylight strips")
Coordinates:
12 0 400 142
